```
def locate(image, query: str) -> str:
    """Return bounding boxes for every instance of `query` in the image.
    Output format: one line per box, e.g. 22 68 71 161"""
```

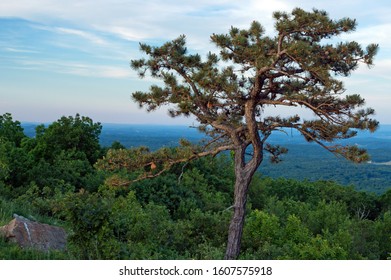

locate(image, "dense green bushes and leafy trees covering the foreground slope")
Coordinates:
0 114 391 259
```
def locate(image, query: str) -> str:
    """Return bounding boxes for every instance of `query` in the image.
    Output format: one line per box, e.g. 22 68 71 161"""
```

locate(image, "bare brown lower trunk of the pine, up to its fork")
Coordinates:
224 147 262 260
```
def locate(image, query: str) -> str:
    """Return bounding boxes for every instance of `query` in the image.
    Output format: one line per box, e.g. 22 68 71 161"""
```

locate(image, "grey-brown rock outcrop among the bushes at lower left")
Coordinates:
0 214 67 251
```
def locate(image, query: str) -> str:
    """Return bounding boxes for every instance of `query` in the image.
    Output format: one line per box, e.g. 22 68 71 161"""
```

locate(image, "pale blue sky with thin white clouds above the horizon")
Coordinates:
0 0 391 125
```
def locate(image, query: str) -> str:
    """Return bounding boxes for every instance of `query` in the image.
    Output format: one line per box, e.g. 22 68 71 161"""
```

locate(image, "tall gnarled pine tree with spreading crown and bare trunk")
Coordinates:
99 8 378 259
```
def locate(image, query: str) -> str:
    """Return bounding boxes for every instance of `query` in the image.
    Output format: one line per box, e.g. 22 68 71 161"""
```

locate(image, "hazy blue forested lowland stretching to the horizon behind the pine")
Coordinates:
22 123 391 194
